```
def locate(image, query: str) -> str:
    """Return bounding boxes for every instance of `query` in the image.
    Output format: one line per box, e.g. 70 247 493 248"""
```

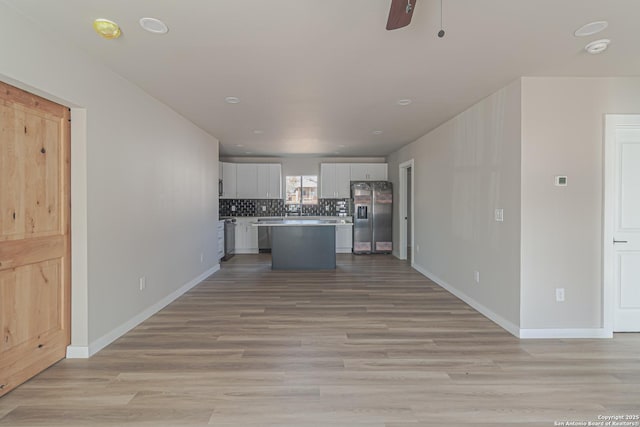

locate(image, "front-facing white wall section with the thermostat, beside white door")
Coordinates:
521 78 640 329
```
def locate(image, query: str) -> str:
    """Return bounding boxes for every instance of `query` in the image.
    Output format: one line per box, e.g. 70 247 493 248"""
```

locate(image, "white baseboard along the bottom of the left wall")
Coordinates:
67 264 220 359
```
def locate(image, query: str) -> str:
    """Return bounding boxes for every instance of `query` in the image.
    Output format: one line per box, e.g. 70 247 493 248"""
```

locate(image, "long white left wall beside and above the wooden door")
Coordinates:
0 3 218 352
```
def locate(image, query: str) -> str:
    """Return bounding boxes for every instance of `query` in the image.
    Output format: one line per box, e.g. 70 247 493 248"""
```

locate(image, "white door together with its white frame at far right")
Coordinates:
603 114 640 332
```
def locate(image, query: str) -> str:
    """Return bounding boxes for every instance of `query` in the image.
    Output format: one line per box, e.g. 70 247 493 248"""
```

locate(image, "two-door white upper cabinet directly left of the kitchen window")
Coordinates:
236 163 282 199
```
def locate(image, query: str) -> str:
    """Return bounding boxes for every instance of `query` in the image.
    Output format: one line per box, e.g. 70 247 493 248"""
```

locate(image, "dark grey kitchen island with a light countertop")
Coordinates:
252 219 353 270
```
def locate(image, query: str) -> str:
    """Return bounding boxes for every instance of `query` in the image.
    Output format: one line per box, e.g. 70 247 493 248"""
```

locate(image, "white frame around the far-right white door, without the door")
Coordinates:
602 114 640 335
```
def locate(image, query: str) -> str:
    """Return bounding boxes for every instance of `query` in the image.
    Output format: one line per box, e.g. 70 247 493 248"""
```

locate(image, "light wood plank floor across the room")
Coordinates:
0 254 640 427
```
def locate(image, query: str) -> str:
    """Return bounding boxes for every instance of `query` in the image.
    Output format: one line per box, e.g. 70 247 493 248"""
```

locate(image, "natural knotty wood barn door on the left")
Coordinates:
0 82 71 396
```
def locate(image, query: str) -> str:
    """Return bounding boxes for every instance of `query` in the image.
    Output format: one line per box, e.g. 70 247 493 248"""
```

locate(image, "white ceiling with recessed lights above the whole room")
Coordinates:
4 0 640 157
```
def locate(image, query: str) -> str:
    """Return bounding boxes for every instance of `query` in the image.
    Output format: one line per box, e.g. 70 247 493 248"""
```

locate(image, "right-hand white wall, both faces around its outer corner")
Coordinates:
388 77 640 337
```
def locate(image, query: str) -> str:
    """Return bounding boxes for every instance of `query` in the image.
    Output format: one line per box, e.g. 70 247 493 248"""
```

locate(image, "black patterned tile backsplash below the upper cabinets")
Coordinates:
219 199 350 217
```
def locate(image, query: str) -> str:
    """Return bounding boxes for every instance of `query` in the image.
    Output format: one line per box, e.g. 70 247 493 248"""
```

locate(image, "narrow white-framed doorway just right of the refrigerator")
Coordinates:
398 159 415 266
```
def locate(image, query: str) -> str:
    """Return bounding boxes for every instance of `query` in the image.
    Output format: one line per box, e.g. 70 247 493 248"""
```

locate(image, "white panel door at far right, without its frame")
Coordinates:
611 123 640 332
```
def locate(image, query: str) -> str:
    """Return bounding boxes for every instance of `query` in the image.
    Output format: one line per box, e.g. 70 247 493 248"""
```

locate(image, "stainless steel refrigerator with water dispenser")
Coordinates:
351 181 393 254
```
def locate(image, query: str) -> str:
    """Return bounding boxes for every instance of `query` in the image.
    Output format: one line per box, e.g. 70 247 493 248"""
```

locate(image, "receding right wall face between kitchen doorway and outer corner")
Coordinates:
387 81 521 333
